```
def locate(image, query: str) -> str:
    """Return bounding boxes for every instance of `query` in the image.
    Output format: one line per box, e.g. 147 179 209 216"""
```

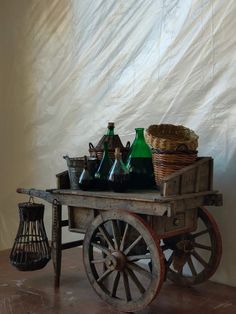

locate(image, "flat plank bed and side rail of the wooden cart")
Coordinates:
18 189 219 216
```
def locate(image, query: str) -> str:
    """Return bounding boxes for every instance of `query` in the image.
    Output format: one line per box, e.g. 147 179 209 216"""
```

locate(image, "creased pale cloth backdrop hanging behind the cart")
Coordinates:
0 0 236 286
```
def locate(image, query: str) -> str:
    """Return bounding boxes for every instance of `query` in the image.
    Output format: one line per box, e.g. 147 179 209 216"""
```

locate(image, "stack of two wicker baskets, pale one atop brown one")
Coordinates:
145 124 198 186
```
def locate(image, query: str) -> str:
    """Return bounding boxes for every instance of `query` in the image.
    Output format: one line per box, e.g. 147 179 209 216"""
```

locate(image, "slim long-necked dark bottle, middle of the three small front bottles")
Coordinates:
95 141 112 190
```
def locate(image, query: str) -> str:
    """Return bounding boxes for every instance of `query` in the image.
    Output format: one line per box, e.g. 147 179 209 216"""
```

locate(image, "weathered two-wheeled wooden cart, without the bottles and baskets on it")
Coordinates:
18 157 222 312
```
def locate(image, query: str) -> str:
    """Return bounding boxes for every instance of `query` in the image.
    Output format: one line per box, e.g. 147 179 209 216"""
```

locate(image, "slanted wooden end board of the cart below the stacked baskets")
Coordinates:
160 157 213 196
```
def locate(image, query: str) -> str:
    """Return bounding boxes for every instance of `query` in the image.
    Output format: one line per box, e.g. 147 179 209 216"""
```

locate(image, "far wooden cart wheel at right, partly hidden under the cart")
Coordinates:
162 208 222 286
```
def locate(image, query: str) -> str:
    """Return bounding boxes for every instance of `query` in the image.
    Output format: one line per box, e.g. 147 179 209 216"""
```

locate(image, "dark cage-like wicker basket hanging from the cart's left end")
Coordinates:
10 199 51 271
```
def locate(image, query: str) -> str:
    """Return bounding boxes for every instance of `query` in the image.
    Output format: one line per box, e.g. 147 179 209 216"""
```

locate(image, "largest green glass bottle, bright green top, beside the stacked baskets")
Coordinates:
126 128 154 189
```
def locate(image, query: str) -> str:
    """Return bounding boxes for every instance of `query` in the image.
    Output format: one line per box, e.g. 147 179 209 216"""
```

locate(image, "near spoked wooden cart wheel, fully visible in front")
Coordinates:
83 210 165 312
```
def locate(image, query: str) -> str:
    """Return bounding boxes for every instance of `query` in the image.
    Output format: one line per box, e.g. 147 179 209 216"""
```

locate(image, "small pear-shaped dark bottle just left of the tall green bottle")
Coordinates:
108 147 129 192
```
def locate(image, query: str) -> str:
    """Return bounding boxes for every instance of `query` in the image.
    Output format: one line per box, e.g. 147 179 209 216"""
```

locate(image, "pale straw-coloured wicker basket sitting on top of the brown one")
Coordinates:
145 124 198 151
